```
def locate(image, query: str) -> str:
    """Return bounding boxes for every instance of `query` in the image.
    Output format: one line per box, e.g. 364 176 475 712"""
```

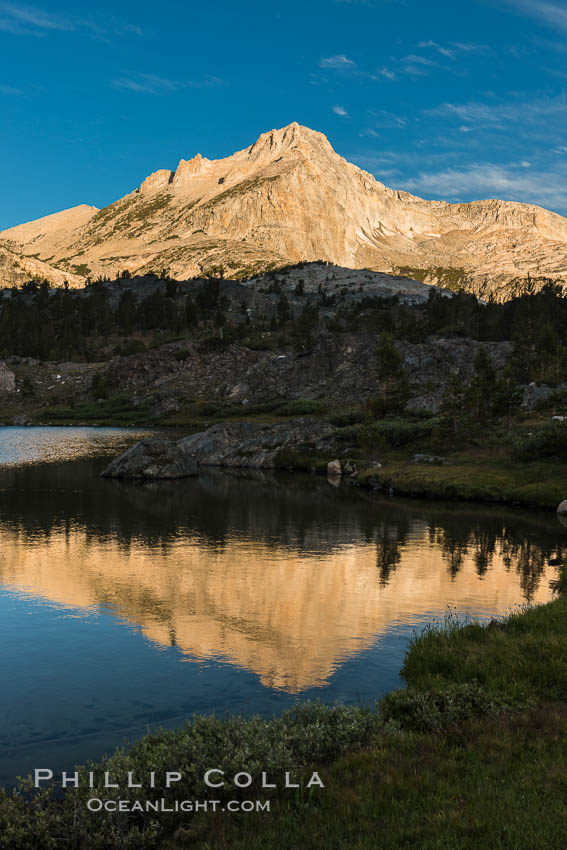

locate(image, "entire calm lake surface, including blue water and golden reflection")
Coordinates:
0 428 567 783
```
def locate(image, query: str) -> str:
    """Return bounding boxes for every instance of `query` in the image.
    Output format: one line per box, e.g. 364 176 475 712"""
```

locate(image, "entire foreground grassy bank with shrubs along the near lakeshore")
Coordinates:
4 568 567 850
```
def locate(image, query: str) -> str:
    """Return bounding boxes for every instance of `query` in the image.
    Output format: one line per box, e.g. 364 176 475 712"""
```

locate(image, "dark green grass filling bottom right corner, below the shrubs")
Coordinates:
191 707 567 850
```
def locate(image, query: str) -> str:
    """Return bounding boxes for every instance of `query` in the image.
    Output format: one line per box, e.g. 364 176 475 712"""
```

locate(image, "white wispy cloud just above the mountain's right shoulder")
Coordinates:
401 162 567 209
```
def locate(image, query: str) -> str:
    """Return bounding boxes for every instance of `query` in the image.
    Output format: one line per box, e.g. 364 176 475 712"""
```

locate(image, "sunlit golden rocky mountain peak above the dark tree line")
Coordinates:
0 123 567 299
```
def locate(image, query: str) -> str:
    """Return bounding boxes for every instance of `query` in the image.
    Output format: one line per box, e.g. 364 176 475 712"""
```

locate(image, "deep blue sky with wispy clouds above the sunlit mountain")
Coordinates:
0 0 567 228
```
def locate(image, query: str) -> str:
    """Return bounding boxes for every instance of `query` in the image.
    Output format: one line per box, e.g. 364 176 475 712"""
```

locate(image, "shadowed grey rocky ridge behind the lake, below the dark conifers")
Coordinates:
104 333 512 413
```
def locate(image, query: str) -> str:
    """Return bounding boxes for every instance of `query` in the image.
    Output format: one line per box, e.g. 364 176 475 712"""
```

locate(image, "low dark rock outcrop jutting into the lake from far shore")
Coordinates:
102 418 336 479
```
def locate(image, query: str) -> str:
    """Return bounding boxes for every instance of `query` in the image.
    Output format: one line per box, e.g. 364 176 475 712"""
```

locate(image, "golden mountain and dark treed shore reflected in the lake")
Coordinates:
0 461 567 693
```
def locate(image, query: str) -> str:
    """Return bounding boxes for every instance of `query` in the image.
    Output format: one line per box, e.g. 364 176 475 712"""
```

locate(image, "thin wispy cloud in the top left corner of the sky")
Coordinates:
0 2 142 38
